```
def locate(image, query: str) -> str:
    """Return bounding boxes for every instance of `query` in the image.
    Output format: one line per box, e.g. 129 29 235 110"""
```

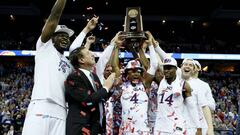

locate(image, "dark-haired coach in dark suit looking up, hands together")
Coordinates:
65 47 115 135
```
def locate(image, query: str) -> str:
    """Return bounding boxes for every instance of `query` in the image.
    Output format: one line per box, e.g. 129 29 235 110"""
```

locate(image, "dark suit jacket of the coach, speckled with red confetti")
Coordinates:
65 69 108 135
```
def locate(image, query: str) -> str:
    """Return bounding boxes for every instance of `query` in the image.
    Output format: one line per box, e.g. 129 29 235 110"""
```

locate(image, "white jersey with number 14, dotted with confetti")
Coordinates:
154 77 186 134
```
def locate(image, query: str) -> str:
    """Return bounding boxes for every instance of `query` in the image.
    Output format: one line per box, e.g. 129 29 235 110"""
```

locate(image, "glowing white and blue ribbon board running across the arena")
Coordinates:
0 50 240 60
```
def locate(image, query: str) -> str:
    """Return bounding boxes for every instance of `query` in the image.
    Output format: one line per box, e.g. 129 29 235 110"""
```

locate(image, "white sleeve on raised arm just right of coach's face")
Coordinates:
96 43 114 84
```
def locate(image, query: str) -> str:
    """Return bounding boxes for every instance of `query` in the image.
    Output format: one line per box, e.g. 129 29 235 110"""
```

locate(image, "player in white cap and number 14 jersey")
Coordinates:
154 57 194 135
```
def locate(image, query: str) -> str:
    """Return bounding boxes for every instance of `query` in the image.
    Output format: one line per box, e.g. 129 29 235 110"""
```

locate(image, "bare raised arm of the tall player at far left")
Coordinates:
41 0 66 43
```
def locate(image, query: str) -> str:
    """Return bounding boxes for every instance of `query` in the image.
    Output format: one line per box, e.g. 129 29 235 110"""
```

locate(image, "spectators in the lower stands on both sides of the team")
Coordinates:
0 63 240 135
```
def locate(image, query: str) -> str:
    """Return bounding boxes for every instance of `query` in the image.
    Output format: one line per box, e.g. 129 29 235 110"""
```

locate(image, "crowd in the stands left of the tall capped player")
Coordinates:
0 63 33 135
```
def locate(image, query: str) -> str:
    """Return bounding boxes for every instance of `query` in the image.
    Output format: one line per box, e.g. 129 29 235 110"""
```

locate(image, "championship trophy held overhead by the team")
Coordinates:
124 7 146 52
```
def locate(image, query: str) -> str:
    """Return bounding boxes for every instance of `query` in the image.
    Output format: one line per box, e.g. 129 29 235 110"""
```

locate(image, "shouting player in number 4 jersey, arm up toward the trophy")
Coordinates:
113 33 158 135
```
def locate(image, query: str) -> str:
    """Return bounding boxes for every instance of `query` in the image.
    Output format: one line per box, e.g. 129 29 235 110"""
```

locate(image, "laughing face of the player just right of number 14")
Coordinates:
181 59 195 80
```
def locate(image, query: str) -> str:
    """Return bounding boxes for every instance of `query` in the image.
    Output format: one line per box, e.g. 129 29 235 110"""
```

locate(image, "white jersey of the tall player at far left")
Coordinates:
31 38 73 117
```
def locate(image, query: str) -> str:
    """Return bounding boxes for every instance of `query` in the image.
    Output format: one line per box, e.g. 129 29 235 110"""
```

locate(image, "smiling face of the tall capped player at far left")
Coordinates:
53 32 70 52
